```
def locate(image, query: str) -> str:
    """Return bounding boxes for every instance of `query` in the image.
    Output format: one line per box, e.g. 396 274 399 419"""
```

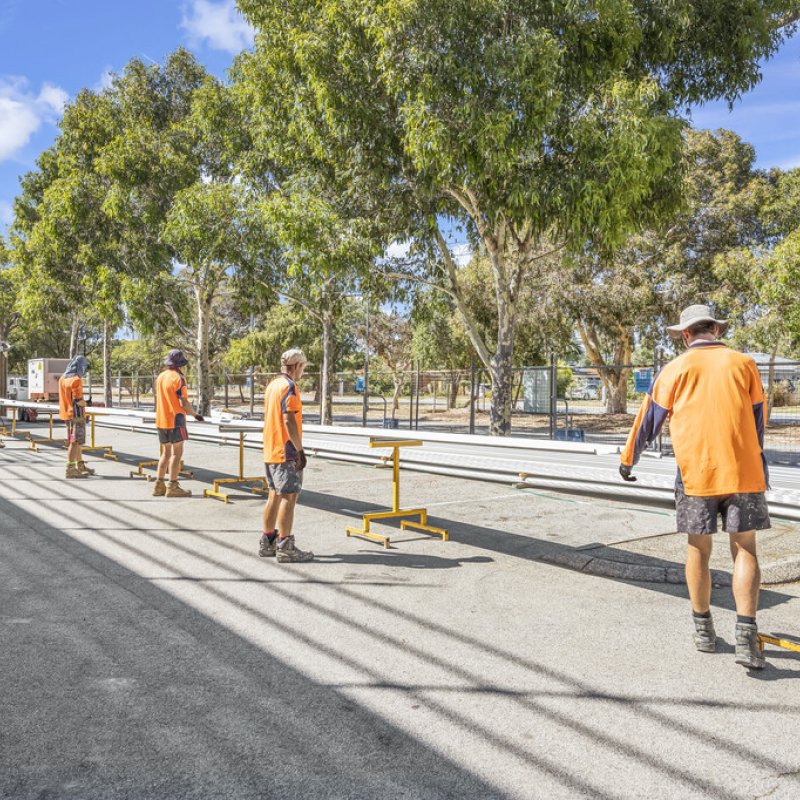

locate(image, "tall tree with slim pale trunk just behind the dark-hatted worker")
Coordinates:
99 49 258 413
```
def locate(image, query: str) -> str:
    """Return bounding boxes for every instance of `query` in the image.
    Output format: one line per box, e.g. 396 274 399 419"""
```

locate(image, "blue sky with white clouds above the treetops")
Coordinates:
0 0 800 236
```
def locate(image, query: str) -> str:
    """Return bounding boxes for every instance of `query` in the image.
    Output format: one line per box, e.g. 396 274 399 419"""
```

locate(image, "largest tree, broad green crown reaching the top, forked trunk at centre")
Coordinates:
236 0 797 434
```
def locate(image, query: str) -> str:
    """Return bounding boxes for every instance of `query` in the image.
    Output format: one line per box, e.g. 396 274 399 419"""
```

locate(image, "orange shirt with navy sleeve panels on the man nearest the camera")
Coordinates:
620 340 768 497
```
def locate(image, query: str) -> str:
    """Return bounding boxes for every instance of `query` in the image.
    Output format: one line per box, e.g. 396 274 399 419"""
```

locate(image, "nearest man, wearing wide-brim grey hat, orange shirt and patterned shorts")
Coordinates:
619 305 770 669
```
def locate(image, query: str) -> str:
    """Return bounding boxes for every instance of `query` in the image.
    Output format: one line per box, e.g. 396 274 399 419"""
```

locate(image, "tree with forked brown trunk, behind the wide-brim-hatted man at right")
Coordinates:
551 129 767 413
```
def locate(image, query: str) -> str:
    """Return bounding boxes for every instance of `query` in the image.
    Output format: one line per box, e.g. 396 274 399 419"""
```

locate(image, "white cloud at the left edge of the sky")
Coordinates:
0 77 69 161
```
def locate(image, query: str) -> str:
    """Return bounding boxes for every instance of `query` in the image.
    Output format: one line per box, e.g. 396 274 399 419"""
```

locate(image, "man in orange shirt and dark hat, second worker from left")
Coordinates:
153 350 203 497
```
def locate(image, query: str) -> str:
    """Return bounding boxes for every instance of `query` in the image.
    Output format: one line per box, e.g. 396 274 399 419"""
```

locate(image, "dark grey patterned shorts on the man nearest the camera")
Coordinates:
675 484 772 533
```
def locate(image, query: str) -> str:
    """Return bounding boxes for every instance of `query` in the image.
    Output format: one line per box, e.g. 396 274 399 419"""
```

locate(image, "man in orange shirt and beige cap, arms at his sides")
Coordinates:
258 347 314 563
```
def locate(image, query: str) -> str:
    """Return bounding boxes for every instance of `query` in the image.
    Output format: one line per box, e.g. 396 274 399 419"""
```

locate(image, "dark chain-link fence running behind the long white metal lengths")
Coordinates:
86 360 800 463
